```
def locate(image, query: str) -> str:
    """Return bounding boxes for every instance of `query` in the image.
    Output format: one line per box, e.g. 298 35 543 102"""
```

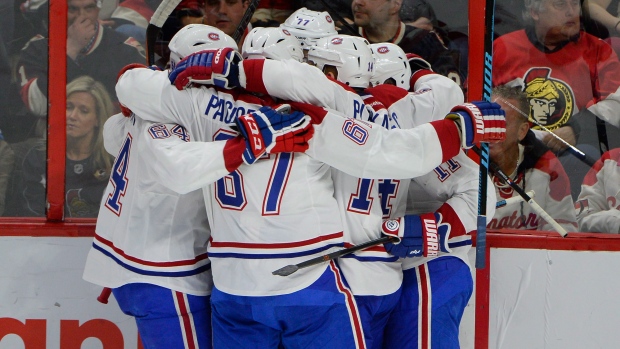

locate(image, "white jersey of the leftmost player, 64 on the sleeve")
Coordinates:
84 114 245 295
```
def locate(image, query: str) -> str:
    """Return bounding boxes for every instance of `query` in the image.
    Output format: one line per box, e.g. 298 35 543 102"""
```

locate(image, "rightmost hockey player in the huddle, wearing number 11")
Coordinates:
367 43 496 349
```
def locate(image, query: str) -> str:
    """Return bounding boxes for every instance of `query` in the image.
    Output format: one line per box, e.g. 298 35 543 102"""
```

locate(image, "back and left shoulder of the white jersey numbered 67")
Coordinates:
117 69 343 296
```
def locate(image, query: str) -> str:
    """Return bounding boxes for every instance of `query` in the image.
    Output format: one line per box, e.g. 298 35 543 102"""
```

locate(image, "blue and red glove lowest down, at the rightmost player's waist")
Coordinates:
382 213 451 258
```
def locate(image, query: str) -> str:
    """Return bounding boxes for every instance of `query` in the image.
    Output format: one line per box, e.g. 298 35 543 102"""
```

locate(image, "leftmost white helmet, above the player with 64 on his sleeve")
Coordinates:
168 24 239 67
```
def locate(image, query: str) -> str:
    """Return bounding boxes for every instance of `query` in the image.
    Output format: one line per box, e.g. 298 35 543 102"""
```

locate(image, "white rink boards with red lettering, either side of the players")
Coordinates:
0 233 620 349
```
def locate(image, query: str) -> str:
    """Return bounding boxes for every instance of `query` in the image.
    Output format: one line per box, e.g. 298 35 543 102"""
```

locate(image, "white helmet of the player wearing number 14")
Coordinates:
308 35 375 88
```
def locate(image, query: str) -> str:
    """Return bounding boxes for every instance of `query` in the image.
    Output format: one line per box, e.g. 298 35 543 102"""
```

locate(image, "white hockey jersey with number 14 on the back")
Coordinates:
241 61 470 295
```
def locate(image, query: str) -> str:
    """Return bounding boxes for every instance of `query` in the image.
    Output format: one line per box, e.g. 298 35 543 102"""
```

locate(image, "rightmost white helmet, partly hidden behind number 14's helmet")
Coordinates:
370 43 411 90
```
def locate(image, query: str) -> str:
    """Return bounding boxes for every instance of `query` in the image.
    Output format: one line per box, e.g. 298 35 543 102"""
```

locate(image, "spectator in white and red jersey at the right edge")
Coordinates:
575 148 620 234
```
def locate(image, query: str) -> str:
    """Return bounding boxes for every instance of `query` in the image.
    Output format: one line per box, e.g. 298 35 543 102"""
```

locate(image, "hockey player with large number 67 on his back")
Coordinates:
130 25 501 348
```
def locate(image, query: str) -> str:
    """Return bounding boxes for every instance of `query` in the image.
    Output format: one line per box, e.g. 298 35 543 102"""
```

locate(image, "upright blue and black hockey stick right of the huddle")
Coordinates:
476 0 495 269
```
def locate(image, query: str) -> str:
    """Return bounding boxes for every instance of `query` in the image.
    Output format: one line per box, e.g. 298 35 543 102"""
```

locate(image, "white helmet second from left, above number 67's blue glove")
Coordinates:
241 27 304 62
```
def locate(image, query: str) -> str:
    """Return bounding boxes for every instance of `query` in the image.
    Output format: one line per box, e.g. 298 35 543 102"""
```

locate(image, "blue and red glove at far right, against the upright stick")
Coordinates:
446 102 506 149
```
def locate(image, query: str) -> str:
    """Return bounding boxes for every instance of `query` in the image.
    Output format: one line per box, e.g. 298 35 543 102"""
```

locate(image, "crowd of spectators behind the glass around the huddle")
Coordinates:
0 0 620 233
